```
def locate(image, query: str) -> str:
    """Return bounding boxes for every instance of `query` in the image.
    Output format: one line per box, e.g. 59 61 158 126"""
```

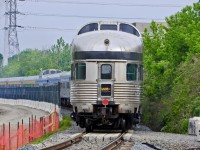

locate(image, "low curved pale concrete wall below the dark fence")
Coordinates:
0 98 60 115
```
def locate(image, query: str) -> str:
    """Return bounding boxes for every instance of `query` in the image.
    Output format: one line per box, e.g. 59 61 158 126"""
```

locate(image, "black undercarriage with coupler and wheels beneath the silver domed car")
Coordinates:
71 104 139 132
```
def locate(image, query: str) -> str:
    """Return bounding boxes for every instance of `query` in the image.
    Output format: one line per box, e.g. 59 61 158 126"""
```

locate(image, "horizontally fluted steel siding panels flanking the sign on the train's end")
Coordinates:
71 83 142 103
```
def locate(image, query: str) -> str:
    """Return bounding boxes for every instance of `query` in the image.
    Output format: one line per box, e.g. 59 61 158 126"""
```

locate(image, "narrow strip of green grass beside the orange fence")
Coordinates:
32 115 72 144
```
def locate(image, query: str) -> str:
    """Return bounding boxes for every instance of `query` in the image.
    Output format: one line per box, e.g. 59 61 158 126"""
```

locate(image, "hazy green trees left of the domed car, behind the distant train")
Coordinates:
0 38 71 77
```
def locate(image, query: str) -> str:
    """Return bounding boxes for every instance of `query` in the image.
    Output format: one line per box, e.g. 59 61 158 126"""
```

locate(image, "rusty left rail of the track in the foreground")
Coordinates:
41 132 86 150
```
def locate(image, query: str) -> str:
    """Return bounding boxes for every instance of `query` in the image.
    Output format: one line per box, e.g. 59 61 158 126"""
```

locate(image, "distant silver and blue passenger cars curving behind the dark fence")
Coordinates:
0 69 71 107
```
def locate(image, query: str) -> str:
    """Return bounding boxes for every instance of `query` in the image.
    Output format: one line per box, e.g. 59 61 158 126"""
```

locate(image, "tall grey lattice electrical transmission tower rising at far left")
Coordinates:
4 0 19 66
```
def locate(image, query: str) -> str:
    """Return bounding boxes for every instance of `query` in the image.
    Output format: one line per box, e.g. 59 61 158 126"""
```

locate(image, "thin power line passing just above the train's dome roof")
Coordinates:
22 12 165 21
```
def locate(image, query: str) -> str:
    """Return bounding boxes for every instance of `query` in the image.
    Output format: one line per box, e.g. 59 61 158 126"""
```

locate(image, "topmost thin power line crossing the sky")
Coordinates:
20 0 184 7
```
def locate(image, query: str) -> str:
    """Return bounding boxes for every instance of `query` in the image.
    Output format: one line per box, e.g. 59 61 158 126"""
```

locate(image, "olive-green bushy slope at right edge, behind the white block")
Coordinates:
162 55 200 133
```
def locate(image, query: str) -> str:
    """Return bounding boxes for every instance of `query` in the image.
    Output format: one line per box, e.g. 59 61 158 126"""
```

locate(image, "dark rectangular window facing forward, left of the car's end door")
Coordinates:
76 63 86 80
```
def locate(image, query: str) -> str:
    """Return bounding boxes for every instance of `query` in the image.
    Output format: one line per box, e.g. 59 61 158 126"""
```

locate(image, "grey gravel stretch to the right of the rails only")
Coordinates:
127 131 200 150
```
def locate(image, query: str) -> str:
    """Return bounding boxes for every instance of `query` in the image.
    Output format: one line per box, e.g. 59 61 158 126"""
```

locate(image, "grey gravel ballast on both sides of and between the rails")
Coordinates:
20 110 200 150
